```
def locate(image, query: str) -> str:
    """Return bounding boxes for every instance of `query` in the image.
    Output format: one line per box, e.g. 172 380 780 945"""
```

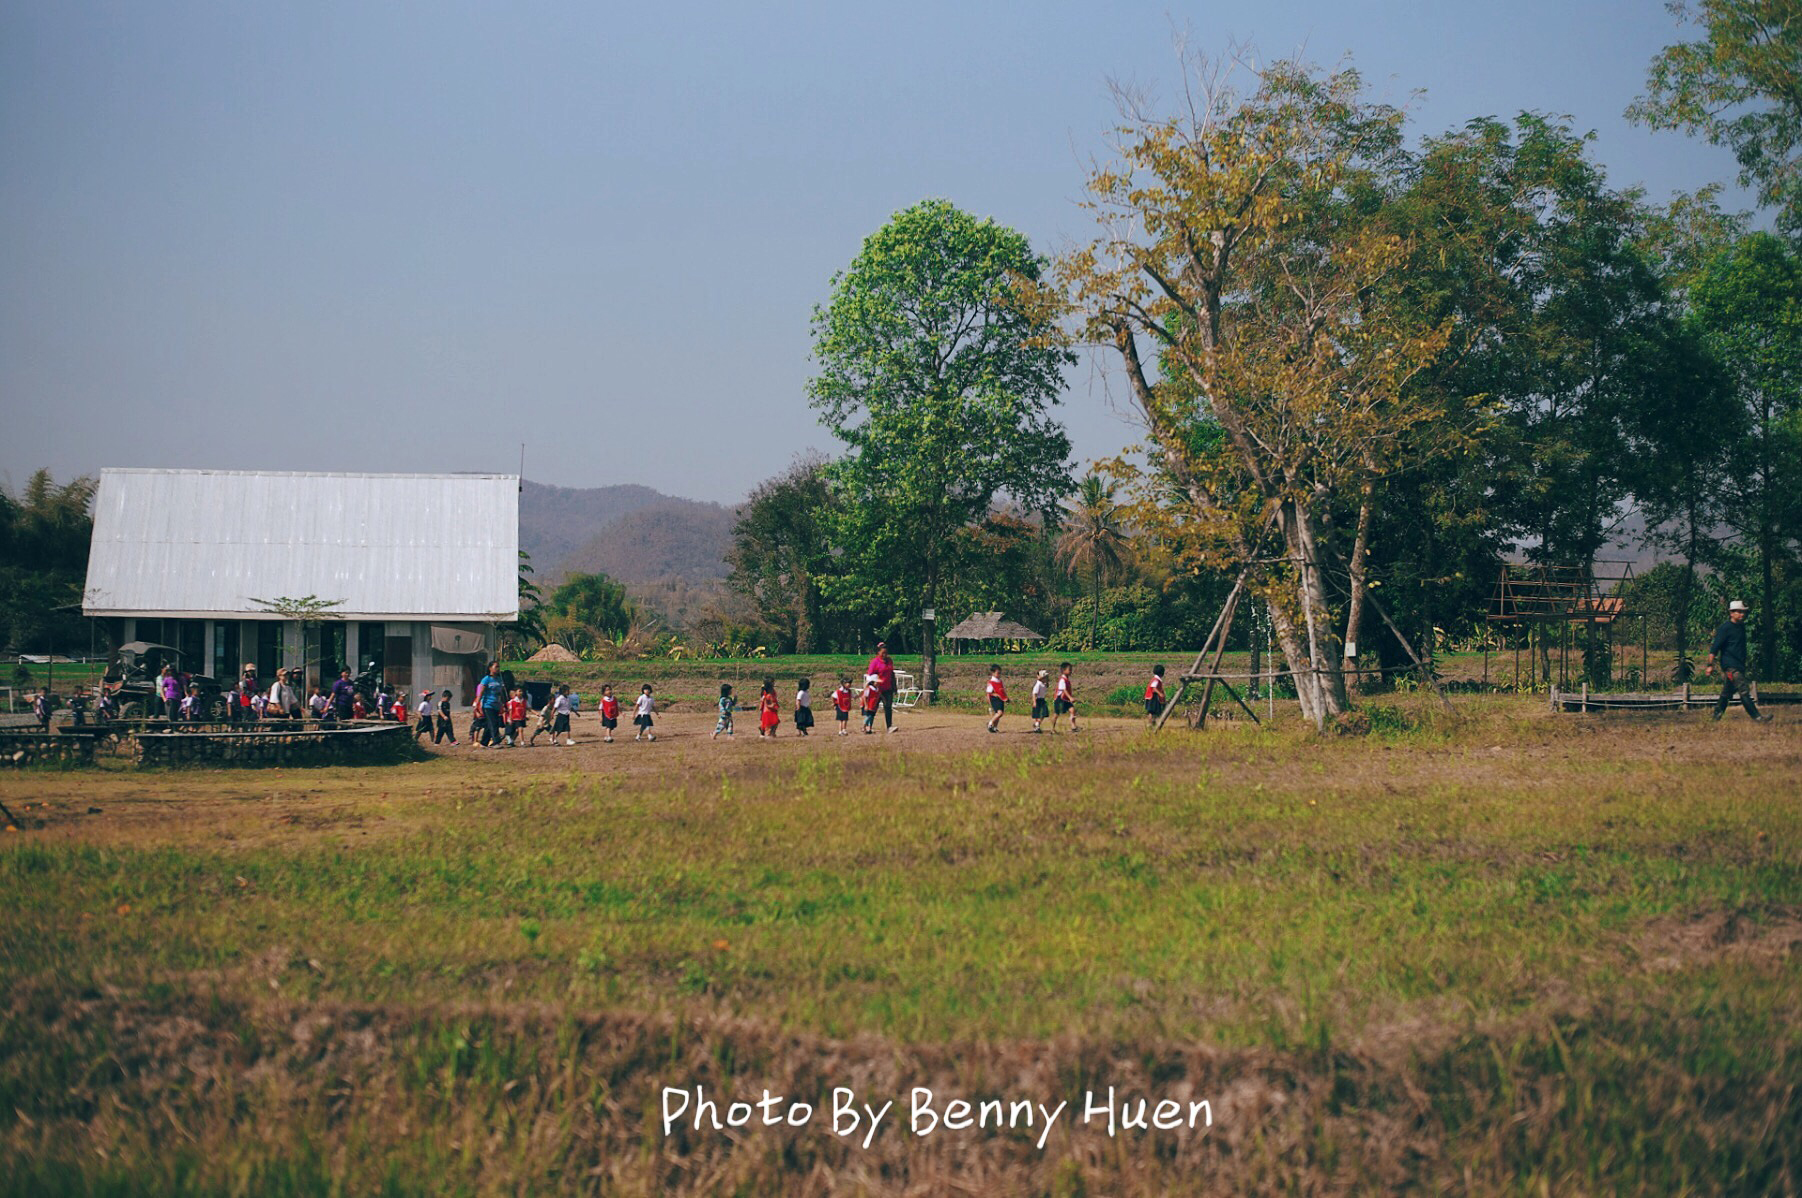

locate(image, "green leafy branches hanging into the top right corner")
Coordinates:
1627 0 1802 236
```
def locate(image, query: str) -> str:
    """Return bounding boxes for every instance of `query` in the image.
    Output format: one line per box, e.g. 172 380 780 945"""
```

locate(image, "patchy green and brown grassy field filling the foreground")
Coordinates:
0 695 1802 1194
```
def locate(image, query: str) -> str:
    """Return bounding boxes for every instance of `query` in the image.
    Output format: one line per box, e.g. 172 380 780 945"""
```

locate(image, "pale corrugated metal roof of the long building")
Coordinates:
81 470 519 622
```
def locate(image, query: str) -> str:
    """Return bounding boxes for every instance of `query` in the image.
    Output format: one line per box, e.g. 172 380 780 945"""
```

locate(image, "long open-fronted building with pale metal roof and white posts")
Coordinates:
81 470 519 703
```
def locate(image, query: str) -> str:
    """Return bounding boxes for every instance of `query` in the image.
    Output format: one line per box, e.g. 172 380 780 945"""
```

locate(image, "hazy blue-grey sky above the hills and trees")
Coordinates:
0 0 1750 503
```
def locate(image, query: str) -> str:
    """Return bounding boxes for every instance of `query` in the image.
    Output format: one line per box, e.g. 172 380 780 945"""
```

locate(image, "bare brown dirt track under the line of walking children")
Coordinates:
0 704 1802 861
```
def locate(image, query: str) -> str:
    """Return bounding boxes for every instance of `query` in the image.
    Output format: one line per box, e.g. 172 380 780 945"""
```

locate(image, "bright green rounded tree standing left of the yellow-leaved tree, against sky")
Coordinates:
807 200 1074 702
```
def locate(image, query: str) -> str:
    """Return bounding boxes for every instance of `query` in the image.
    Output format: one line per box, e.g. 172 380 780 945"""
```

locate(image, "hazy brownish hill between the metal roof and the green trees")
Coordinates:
519 481 735 585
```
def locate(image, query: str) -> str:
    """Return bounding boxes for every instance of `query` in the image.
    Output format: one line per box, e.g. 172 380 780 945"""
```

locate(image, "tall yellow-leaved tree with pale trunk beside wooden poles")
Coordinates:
1063 61 1460 724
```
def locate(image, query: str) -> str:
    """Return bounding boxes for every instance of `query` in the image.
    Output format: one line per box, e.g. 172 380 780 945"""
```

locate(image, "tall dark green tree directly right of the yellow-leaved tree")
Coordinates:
1379 113 1708 681
